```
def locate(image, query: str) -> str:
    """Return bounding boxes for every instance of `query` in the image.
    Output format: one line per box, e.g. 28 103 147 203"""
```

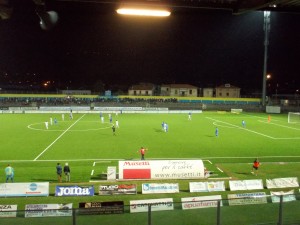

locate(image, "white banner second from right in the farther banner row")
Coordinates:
229 179 264 191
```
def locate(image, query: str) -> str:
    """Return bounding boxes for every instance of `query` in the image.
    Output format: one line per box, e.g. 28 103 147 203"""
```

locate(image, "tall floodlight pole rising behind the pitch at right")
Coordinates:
262 11 271 106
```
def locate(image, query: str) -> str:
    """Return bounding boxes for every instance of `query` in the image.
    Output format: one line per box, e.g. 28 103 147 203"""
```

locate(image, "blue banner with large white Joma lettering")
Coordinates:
55 185 95 196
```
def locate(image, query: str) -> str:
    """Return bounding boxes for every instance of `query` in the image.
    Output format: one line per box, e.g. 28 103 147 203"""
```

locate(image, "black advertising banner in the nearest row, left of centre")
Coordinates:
79 201 124 215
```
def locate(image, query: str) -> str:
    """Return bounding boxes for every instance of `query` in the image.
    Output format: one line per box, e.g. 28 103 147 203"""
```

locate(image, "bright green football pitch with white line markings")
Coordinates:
0 112 300 224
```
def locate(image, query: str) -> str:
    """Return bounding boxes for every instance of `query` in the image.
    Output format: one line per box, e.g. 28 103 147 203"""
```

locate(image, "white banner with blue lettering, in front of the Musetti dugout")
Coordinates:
142 183 179 194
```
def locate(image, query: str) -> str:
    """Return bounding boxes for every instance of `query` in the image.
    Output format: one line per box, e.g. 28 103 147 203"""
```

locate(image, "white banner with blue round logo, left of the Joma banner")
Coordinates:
0 182 49 197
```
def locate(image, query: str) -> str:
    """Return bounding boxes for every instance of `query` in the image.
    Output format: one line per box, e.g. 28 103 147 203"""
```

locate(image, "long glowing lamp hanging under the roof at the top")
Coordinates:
117 8 171 17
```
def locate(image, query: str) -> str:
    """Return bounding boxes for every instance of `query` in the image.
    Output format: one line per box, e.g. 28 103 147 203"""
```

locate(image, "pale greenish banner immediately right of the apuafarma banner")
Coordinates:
228 192 267 205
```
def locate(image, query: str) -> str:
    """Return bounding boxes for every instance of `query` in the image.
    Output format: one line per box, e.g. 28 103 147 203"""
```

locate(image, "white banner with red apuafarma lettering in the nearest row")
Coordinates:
181 195 222 210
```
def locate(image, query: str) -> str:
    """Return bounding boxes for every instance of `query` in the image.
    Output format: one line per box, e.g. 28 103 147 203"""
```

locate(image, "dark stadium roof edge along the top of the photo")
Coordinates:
0 0 300 20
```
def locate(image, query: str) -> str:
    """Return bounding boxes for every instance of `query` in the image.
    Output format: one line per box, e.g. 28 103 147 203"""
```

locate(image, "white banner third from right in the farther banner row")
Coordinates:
189 181 225 192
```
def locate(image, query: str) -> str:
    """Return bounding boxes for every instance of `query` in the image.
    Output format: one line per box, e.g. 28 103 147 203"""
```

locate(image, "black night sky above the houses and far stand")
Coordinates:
0 0 300 94
